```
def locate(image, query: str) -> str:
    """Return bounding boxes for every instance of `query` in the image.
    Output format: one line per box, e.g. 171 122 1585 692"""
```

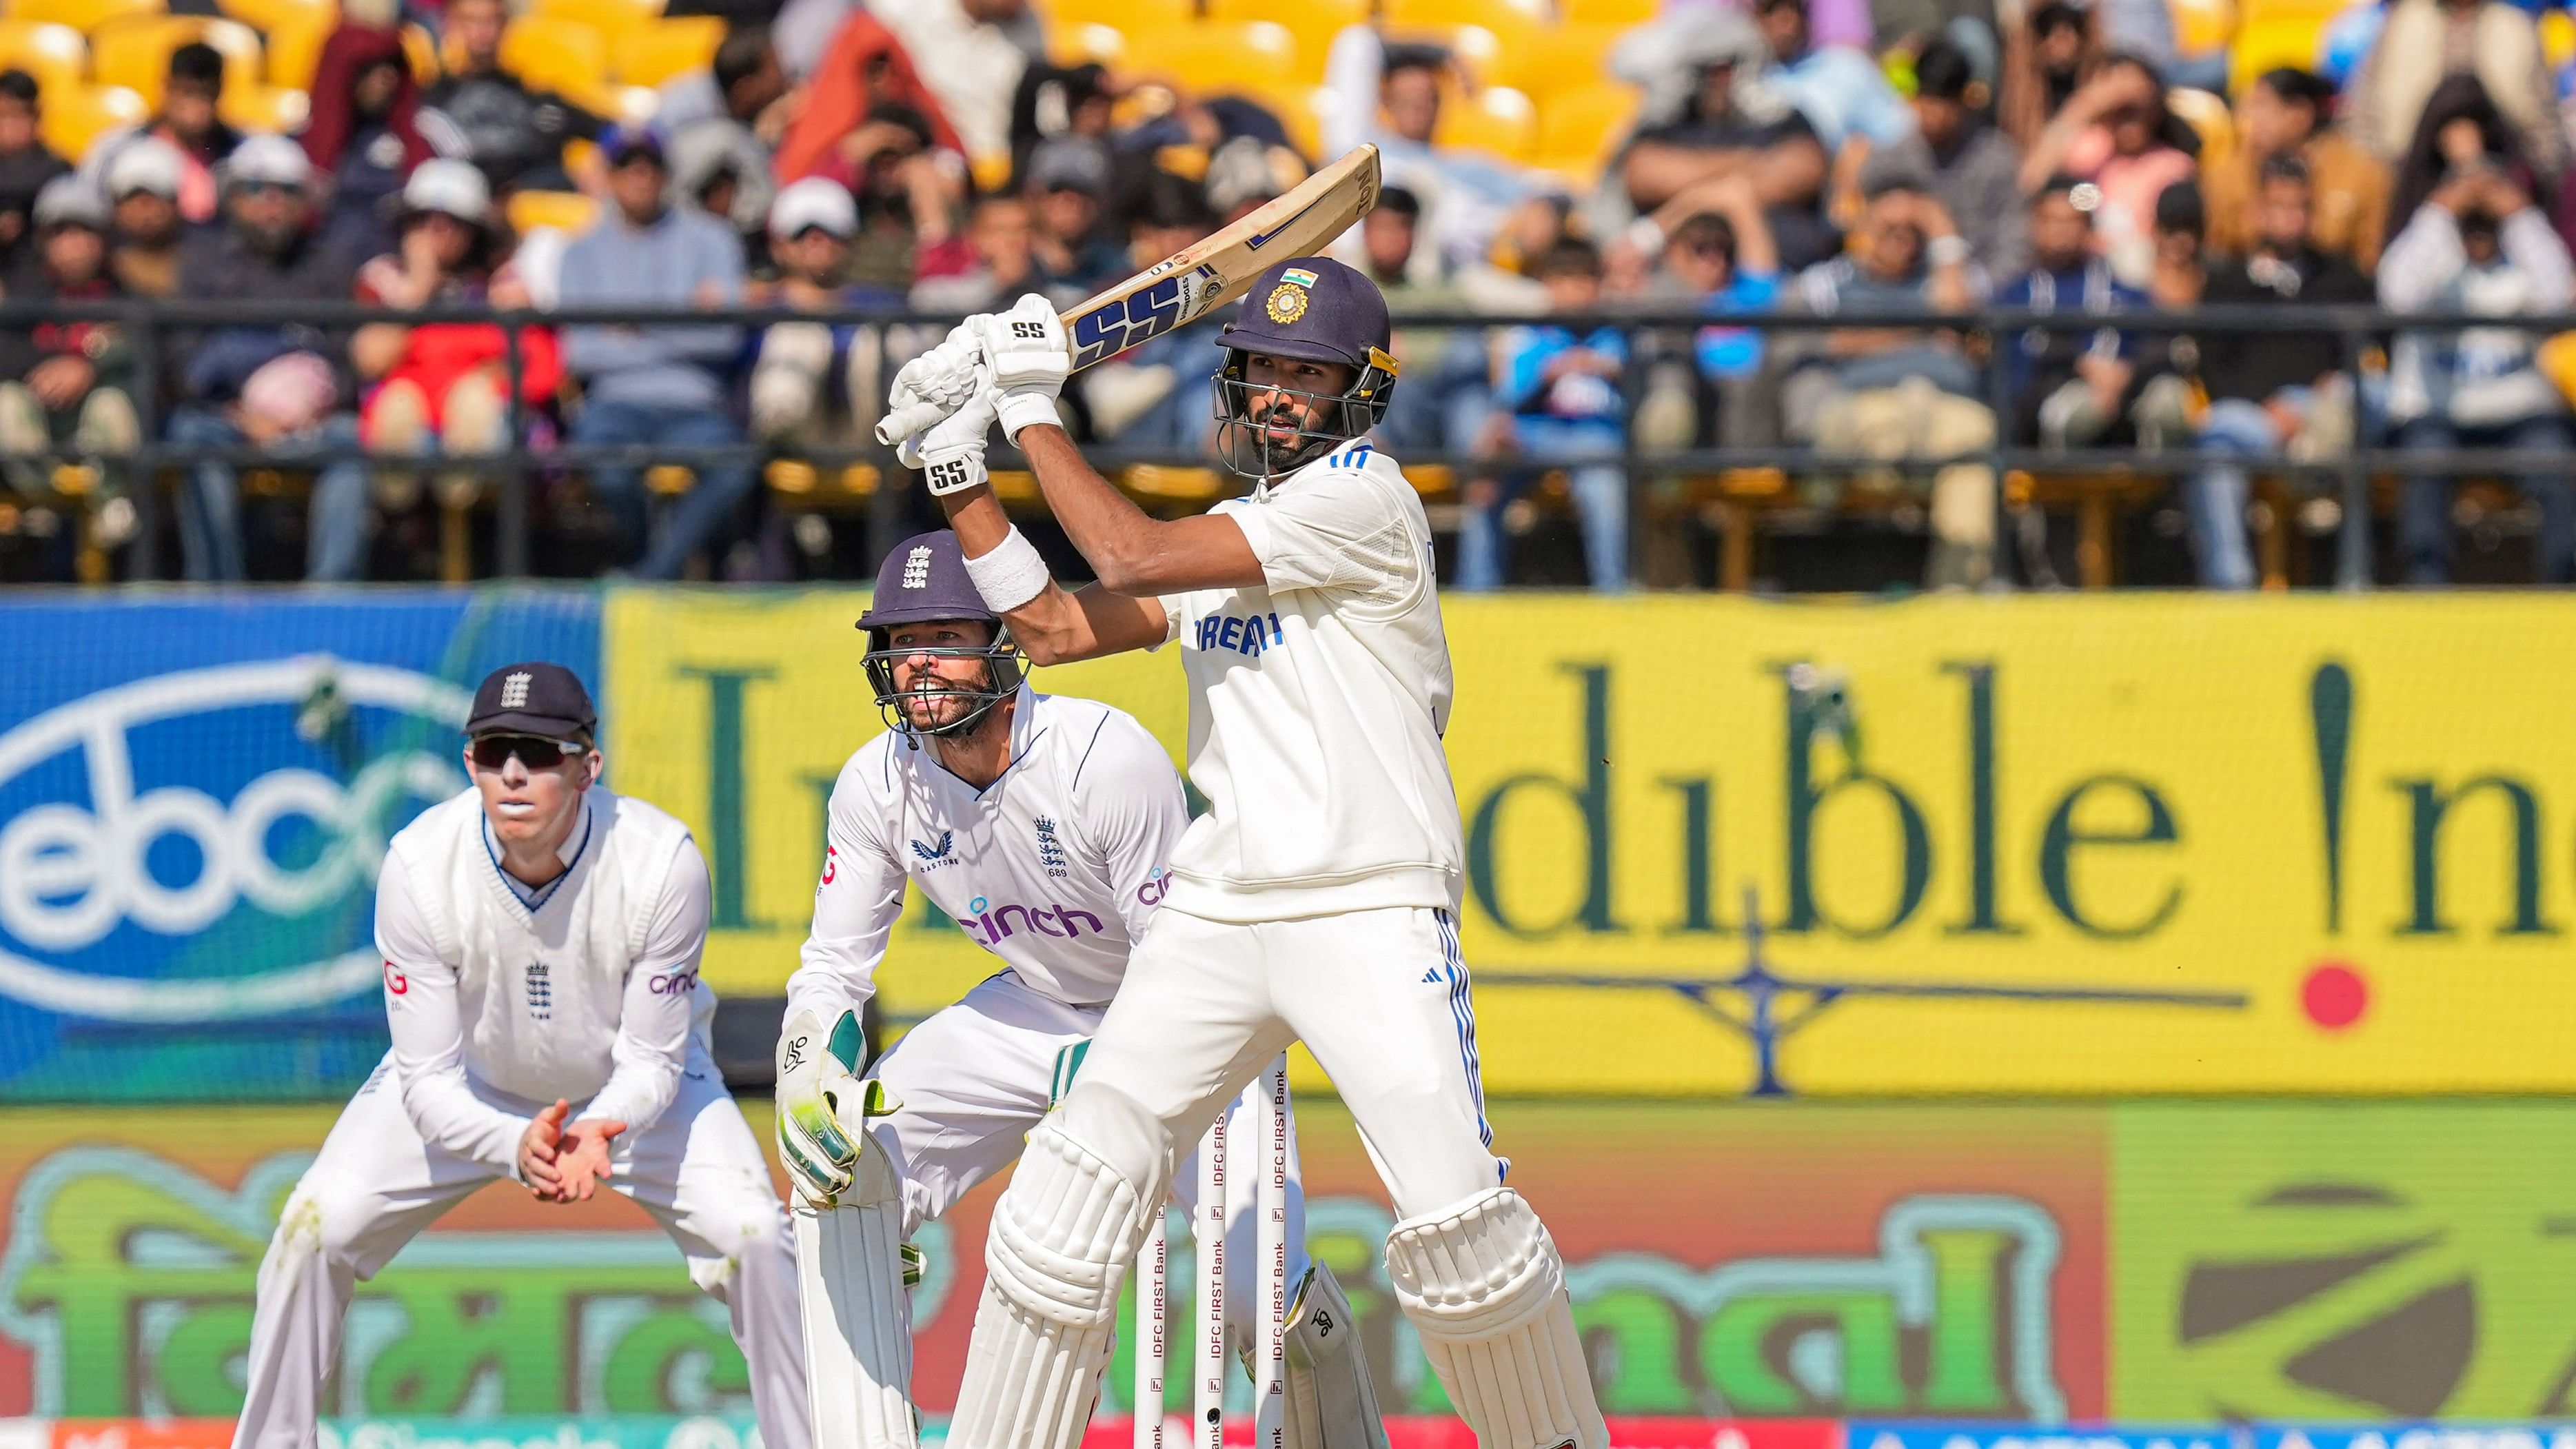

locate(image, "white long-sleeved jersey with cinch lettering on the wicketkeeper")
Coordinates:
789 683 1190 1021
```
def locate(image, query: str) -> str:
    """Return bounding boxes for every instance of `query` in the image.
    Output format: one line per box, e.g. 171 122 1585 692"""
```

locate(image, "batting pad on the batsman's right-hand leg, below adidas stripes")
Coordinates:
1386 1188 1610 1449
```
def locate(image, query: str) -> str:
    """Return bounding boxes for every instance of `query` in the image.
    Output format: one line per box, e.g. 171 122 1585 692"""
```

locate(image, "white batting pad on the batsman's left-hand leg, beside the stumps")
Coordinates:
948 1119 1146 1449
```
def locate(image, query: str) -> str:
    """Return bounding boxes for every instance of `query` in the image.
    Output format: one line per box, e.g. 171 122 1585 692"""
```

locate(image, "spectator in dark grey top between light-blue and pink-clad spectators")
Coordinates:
1855 39 2030 276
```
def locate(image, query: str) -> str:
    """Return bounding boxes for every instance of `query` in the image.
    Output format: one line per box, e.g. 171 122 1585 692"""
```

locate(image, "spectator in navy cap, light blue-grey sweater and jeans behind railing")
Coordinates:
562 126 755 578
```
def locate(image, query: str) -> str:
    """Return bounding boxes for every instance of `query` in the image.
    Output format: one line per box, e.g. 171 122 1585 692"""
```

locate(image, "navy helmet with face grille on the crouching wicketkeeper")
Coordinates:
858 529 1023 748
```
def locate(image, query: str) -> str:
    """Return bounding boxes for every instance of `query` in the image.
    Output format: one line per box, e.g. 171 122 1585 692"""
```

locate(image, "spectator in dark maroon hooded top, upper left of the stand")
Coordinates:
296 21 430 255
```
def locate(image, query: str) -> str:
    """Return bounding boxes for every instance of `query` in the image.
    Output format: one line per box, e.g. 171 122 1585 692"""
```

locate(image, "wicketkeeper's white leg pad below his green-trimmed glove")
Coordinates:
791 1139 915 1449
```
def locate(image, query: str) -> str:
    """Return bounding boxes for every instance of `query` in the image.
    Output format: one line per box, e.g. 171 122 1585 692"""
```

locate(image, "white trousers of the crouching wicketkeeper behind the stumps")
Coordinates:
865 972 1306 1330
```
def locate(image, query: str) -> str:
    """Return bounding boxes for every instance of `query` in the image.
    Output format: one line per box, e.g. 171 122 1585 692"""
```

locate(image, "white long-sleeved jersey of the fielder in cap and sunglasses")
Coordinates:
376 784 716 1171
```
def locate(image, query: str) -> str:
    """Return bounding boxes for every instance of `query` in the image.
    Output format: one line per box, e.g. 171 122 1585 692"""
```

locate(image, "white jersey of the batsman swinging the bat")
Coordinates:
1162 441 1466 920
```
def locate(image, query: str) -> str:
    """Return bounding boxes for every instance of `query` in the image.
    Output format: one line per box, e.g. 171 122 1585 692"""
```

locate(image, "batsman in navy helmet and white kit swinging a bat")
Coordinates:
896 258 1610 1449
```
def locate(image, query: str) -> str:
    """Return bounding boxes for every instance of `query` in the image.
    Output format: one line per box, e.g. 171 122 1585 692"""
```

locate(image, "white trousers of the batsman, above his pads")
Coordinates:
1064 905 1502 1219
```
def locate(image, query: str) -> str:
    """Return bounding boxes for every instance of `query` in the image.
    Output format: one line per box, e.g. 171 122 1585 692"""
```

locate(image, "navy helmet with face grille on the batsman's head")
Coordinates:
1213 258 1396 480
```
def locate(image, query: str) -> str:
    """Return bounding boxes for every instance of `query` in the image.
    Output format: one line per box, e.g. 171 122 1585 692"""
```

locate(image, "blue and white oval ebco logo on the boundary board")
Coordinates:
0 655 471 1024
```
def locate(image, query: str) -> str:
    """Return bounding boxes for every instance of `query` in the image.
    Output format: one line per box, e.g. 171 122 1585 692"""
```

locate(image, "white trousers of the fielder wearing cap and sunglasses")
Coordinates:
232 1044 811 1449
